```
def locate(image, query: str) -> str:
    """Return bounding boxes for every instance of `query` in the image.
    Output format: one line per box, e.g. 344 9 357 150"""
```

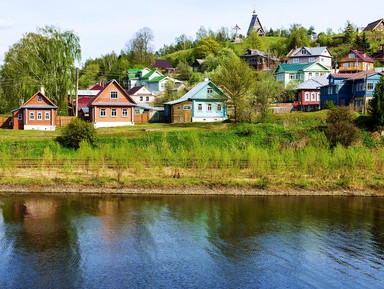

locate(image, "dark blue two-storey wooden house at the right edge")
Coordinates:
320 71 383 112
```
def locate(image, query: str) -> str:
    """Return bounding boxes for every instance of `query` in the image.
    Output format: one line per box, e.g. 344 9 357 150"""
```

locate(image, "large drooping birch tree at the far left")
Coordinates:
0 26 80 113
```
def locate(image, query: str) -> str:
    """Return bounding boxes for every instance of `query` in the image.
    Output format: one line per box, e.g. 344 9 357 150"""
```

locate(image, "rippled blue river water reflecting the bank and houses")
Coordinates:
0 196 384 289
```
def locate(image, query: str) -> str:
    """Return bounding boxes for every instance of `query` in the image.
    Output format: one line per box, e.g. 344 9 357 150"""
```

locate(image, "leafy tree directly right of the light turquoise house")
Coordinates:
212 58 256 122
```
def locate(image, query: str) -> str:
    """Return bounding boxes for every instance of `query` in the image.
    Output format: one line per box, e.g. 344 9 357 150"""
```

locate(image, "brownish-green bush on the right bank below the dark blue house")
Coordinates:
324 106 360 147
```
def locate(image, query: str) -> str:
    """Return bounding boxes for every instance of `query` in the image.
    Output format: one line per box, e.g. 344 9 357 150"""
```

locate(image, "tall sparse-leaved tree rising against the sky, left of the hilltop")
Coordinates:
125 27 154 66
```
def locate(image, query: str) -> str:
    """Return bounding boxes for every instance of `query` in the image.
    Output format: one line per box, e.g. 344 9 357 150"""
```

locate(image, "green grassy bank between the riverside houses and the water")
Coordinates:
0 112 384 191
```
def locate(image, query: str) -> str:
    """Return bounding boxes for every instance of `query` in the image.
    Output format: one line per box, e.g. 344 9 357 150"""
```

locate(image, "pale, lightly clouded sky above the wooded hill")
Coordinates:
0 0 384 65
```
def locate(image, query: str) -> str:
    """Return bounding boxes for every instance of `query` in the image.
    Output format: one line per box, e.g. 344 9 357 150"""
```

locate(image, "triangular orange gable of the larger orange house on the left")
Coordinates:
89 80 136 106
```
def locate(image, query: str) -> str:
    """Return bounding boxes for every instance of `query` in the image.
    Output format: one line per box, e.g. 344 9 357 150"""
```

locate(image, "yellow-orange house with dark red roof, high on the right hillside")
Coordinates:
339 50 375 73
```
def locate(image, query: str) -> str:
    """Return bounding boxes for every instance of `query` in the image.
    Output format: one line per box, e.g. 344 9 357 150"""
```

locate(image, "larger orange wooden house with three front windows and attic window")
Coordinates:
88 80 136 128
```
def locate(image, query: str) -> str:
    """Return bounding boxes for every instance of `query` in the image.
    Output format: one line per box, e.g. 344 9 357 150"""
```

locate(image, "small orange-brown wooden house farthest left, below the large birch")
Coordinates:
12 91 57 130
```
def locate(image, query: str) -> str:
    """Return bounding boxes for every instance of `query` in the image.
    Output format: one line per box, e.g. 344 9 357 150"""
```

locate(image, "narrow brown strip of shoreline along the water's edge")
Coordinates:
0 185 384 197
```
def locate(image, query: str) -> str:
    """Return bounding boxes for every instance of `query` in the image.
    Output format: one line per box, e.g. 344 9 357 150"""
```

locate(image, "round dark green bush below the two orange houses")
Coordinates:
57 118 96 149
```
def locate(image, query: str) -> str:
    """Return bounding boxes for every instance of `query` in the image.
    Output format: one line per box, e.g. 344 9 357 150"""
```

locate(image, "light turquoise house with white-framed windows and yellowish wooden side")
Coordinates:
164 79 229 123
